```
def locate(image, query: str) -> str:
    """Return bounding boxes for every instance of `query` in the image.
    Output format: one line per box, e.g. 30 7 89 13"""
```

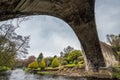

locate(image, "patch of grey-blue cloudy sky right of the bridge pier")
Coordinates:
95 0 120 42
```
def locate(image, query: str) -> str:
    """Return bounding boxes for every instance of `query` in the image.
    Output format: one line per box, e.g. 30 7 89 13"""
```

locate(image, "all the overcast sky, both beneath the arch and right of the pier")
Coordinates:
0 0 120 57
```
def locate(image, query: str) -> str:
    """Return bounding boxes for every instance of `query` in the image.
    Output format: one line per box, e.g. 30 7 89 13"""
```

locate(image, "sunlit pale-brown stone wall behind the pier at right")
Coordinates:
100 42 119 68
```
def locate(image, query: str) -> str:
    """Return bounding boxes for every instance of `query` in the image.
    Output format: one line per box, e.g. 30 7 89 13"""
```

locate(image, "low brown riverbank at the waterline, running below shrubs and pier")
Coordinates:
37 68 112 79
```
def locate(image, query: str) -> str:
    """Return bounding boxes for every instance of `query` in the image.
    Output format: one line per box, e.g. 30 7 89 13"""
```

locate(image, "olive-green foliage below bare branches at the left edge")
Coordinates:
0 36 15 67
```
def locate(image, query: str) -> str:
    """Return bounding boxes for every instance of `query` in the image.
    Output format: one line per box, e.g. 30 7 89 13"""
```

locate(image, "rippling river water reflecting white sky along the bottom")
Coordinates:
0 69 112 80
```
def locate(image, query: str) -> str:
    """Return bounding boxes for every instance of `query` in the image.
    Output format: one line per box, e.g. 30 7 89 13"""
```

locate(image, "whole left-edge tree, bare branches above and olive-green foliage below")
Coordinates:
0 18 30 67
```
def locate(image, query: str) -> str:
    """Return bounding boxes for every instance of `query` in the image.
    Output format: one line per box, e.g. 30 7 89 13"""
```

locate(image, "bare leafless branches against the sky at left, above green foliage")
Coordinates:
0 24 30 56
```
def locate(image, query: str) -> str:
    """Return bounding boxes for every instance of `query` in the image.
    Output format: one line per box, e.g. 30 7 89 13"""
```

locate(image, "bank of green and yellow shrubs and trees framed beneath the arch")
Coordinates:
24 46 85 75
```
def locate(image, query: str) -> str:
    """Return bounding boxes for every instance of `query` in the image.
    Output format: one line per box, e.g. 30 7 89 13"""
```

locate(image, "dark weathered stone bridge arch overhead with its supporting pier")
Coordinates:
0 0 105 70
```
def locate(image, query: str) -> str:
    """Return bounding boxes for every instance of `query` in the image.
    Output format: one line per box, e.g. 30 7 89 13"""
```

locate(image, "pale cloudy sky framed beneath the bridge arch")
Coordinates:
16 16 80 56
